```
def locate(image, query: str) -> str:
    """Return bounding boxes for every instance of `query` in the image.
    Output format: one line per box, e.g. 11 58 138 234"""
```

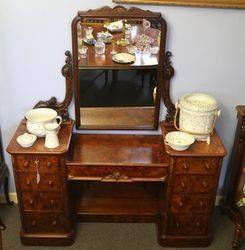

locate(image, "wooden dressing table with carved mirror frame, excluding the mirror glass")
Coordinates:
7 7 226 247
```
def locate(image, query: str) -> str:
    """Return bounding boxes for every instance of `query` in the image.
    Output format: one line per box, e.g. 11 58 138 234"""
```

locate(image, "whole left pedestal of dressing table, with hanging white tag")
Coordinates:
7 122 74 245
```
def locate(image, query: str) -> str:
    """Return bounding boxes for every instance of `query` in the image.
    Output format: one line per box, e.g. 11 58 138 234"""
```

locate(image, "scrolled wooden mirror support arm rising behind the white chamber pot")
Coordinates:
34 51 73 121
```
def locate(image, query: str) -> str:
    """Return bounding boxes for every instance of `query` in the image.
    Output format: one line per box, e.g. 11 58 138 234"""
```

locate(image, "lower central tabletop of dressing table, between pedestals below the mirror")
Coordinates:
67 134 169 166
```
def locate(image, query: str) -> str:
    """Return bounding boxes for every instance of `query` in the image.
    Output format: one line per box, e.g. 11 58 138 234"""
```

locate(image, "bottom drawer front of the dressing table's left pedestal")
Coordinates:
22 212 68 233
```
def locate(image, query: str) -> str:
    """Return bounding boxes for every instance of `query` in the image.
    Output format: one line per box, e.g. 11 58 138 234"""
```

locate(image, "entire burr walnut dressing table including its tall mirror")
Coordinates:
7 7 226 247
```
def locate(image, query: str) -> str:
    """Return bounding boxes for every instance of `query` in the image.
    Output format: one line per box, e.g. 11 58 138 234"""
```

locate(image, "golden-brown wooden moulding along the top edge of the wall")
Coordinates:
113 0 245 9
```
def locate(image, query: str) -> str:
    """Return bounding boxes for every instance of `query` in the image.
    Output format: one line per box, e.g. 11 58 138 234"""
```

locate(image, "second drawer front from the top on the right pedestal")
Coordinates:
173 175 217 193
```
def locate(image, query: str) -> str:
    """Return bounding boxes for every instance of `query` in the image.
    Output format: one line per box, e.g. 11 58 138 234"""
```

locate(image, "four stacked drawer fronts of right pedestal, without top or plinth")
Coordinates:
167 157 222 236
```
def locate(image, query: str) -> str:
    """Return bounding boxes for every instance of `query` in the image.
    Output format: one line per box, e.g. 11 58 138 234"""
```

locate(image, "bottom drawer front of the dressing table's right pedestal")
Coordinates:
168 214 208 235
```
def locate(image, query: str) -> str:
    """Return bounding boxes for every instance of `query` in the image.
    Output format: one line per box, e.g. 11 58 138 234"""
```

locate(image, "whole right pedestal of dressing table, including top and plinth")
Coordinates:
159 122 226 247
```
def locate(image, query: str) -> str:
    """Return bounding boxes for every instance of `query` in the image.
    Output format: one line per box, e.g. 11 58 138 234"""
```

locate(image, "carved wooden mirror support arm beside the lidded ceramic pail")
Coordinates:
162 51 175 121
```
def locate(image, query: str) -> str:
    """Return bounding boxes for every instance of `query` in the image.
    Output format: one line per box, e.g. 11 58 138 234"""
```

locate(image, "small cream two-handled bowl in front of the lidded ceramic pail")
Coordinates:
165 131 195 151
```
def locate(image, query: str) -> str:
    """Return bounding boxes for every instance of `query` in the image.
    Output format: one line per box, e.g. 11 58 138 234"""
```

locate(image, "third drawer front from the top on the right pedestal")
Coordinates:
171 194 212 213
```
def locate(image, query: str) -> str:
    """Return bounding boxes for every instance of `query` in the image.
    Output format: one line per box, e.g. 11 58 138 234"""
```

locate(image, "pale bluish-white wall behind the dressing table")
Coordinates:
0 0 245 191
